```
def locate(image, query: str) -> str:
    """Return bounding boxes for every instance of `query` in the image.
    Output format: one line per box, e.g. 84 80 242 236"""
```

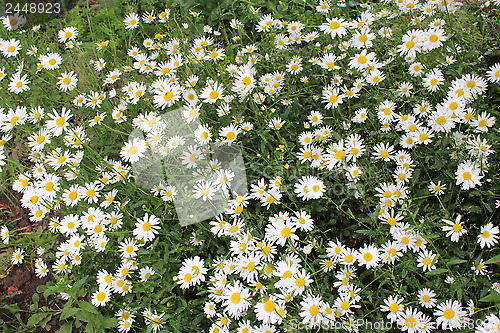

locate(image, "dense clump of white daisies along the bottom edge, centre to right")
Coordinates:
177 211 492 332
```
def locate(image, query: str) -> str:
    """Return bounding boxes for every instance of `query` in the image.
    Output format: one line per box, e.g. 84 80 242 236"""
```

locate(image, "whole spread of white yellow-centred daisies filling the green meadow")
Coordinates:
0 0 500 333
